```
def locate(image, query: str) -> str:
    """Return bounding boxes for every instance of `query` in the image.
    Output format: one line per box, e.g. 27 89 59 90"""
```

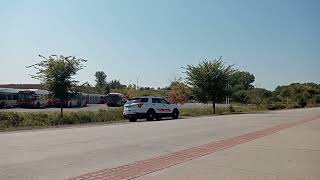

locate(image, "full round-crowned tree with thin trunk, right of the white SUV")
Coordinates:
185 58 235 114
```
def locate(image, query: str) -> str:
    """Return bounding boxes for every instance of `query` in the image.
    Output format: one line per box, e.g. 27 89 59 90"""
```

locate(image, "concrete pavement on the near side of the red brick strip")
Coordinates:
137 119 320 180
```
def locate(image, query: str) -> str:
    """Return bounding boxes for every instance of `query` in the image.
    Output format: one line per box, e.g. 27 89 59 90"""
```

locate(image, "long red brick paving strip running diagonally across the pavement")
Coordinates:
69 116 319 180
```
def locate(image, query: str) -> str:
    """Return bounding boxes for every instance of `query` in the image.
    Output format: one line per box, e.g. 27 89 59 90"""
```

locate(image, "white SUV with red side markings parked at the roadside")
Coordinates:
123 96 179 122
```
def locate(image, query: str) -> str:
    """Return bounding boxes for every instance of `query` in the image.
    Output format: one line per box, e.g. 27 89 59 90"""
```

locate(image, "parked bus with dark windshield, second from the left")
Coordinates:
19 89 49 108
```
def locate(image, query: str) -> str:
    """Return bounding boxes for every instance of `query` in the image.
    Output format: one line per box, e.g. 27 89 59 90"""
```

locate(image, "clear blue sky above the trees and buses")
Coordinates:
0 0 320 89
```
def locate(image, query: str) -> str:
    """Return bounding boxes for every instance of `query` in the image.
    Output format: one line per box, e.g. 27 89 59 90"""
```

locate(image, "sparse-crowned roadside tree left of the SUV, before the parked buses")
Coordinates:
27 55 87 117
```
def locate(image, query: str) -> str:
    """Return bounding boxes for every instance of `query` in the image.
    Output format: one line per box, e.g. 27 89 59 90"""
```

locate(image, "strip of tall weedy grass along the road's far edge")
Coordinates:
0 102 318 130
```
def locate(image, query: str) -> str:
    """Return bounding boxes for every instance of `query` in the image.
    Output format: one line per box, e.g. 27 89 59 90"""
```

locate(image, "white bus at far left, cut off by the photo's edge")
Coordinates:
0 88 19 108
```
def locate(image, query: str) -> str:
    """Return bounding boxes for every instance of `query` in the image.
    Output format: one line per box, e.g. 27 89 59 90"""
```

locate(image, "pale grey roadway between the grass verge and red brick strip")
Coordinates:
0 108 320 180
